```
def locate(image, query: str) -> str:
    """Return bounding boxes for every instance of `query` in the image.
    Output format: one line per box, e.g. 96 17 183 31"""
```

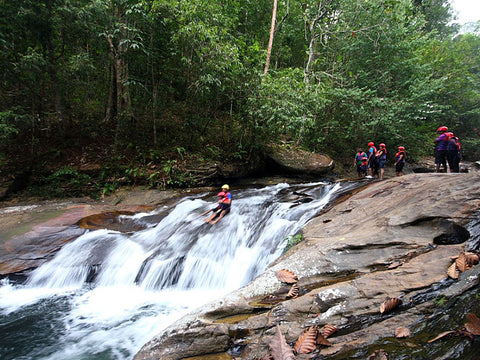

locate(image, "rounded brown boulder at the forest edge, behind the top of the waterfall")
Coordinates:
266 145 335 175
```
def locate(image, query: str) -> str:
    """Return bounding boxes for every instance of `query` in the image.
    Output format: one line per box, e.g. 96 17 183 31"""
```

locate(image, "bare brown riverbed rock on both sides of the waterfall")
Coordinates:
0 173 480 360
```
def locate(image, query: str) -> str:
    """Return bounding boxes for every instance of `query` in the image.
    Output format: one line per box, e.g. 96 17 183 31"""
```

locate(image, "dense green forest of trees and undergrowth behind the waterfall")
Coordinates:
0 0 480 197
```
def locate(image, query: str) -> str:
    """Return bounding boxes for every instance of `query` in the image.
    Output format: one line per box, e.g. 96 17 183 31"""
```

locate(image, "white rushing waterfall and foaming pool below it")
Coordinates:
0 183 352 360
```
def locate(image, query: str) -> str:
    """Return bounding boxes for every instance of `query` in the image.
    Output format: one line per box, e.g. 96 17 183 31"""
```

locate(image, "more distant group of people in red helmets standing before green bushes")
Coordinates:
354 141 407 179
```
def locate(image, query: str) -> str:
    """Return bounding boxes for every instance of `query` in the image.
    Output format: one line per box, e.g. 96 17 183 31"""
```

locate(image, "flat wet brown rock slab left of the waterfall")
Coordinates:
0 202 161 279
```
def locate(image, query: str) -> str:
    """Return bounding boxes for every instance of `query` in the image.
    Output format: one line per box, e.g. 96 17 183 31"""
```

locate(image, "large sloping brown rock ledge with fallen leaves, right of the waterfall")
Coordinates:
134 174 480 360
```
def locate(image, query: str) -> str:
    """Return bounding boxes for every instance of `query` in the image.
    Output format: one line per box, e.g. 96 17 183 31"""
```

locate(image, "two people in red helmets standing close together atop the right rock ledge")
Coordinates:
434 126 462 172
